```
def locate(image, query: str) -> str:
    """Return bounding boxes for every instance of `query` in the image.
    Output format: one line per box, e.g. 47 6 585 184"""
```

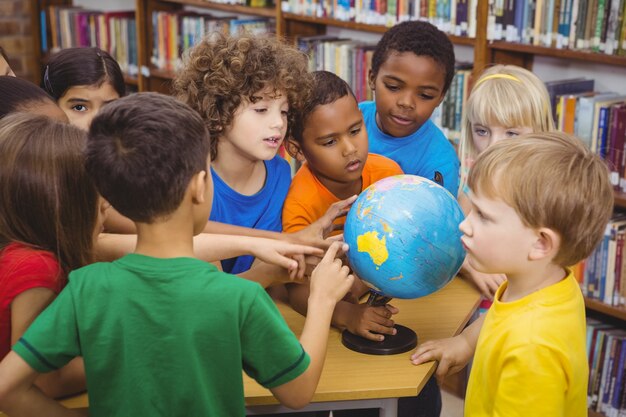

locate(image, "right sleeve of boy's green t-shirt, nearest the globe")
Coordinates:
241 287 311 388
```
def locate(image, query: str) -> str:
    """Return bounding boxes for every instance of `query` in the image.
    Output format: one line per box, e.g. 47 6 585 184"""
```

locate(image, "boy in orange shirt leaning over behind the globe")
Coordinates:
283 71 403 233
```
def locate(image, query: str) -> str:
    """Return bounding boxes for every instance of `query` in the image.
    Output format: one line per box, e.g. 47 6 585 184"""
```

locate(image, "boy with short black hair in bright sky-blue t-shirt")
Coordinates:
359 21 459 197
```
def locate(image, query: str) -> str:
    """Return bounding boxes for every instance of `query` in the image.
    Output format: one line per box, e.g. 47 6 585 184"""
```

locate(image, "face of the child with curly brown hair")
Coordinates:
217 91 289 161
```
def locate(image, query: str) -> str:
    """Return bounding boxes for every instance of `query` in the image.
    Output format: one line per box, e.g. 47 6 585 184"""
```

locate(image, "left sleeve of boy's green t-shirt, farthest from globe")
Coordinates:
13 284 81 373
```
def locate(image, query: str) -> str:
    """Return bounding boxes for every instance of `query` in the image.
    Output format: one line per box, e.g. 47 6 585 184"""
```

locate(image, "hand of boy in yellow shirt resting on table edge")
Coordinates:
411 335 474 382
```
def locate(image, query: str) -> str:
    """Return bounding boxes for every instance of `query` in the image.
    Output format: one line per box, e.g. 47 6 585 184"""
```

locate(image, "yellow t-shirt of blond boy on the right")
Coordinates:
465 271 589 417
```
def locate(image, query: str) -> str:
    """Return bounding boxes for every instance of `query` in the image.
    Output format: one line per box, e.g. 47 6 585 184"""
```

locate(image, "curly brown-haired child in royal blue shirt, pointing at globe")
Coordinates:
173 33 340 282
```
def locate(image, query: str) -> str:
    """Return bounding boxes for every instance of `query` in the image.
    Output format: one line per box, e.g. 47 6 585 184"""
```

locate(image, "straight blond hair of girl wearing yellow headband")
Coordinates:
459 65 555 191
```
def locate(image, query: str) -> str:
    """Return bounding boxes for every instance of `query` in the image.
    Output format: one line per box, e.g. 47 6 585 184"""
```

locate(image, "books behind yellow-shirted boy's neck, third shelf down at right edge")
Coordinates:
574 214 626 307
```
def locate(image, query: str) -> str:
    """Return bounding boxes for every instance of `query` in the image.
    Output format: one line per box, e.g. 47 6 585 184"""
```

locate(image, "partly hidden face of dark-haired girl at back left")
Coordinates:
59 82 120 130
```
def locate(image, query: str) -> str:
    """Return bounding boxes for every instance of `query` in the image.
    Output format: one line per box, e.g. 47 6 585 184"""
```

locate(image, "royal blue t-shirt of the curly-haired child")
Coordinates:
209 156 291 274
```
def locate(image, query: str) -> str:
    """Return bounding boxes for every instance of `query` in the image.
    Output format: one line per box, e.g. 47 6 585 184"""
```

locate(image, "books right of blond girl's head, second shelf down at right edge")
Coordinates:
546 78 626 191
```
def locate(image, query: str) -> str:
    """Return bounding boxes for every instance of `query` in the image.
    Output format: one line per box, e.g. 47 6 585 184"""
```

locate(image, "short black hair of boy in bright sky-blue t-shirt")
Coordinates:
372 20 454 94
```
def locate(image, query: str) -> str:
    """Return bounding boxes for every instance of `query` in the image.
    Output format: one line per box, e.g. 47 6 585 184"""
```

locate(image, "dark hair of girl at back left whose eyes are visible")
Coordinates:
41 47 126 101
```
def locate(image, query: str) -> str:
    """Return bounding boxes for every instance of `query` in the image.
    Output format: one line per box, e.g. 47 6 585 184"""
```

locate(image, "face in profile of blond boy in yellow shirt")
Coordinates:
459 190 537 275
